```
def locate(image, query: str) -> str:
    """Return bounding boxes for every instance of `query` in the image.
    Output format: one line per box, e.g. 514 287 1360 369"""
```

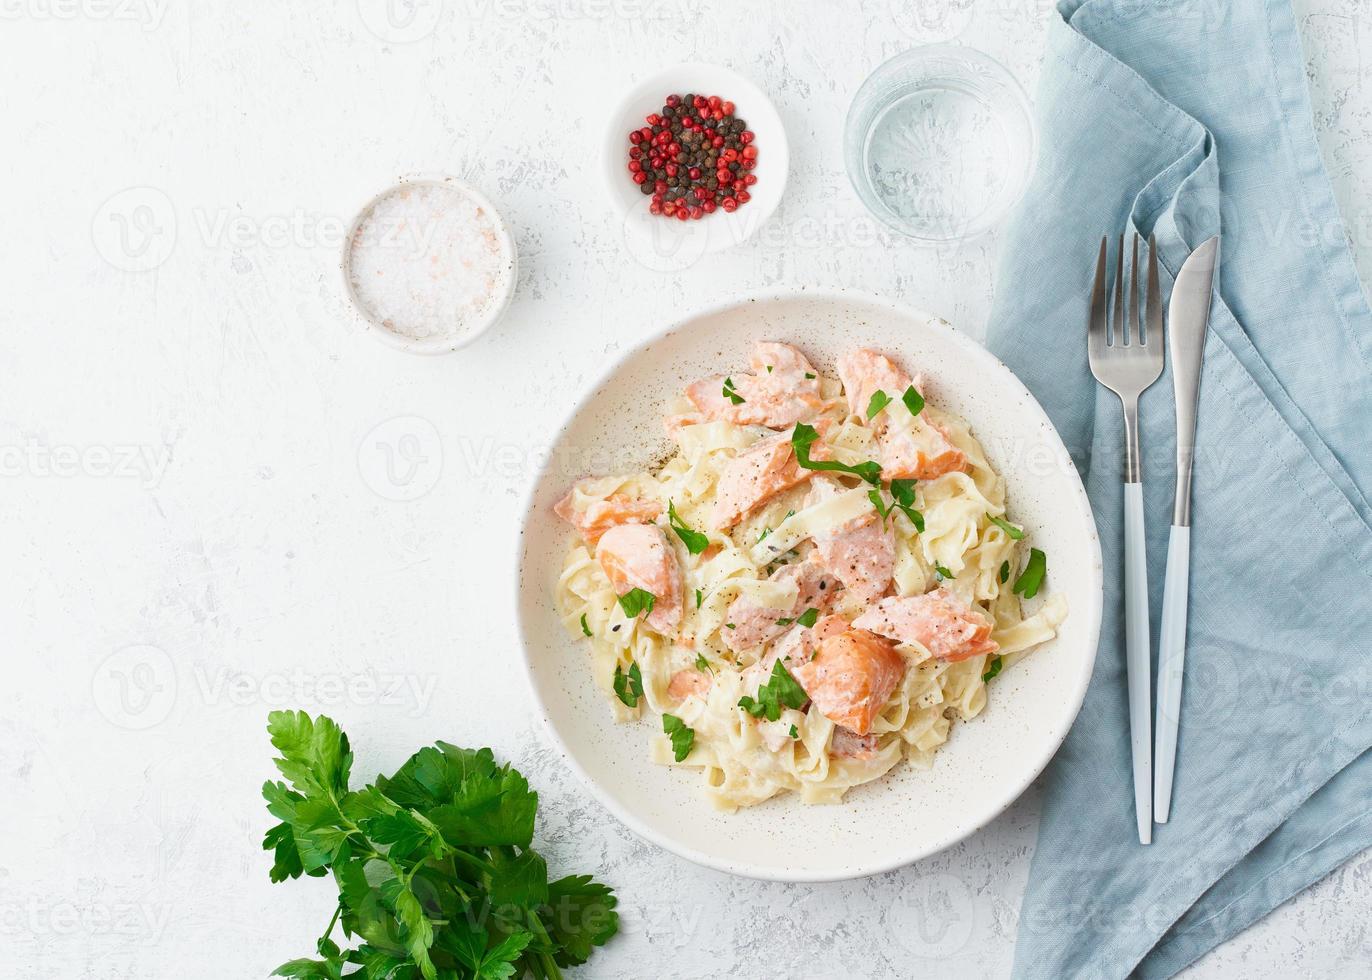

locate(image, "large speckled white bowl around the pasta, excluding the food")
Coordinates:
516 291 1103 881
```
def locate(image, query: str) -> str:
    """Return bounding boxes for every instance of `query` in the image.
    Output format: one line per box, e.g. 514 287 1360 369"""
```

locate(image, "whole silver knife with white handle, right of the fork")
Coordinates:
1152 235 1220 824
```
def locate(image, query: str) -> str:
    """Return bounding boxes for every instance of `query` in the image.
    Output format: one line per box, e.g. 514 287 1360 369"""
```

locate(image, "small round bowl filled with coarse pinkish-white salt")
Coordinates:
348 181 513 340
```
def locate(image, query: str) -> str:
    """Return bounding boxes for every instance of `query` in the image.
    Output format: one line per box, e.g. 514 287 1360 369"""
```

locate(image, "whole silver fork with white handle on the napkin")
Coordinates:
1087 235 1163 844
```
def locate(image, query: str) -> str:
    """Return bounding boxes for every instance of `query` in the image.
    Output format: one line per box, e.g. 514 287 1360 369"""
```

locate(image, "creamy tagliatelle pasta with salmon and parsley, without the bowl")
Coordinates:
556 343 1067 810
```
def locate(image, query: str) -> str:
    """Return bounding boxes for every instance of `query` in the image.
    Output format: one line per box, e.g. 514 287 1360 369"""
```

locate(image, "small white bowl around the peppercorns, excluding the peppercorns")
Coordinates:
601 65 790 270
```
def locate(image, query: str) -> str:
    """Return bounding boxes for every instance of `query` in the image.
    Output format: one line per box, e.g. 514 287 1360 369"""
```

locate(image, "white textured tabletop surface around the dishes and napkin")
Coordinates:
0 0 1372 979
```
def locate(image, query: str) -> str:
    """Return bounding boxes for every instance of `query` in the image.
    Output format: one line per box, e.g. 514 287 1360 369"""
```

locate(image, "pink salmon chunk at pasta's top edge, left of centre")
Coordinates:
686 342 825 428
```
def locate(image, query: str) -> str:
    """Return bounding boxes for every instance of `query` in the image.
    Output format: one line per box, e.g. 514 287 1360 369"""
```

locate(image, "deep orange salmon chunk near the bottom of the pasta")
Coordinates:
790 629 906 736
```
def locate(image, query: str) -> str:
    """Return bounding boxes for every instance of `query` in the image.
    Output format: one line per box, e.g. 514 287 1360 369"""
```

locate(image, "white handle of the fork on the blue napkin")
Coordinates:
1124 483 1152 844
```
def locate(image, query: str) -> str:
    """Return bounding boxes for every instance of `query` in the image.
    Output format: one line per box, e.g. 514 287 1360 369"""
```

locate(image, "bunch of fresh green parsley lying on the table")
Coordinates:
262 711 619 980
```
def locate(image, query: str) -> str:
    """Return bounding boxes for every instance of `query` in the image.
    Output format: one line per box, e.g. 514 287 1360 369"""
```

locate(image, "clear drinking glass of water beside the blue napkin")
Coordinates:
844 44 1034 244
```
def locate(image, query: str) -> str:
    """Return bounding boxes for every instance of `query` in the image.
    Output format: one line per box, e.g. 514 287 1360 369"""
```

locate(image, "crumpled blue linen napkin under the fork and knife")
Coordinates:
989 0 1372 977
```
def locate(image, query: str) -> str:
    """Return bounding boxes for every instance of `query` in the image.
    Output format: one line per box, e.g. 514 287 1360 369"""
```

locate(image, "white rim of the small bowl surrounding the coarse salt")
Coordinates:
340 173 519 354
